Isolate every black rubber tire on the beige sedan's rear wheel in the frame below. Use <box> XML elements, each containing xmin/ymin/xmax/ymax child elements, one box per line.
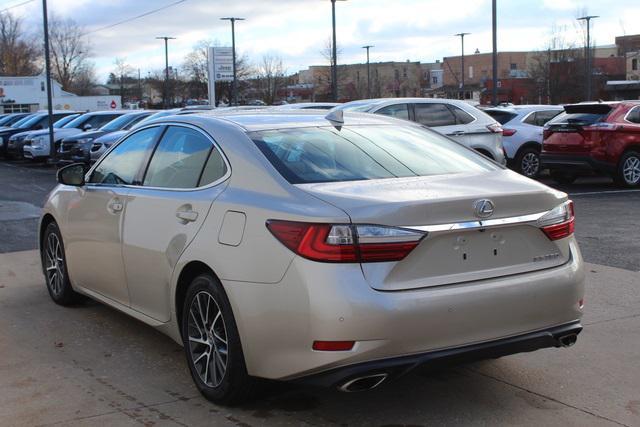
<box><xmin>181</xmin><ymin>273</ymin><xmax>257</xmax><ymax>405</ymax></box>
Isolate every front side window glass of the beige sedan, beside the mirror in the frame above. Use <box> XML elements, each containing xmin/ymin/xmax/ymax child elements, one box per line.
<box><xmin>89</xmin><ymin>127</ymin><xmax>161</xmax><ymax>185</ymax></box>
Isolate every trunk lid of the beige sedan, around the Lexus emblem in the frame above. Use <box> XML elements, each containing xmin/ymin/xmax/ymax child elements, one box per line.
<box><xmin>297</xmin><ymin>170</ymin><xmax>569</xmax><ymax>291</ymax></box>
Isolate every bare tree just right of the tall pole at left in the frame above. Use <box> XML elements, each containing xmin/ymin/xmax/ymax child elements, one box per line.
<box><xmin>49</xmin><ymin>16</ymin><xmax>91</xmax><ymax>90</ymax></box>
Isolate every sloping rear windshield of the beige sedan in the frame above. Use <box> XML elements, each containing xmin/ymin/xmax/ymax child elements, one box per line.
<box><xmin>249</xmin><ymin>125</ymin><xmax>500</xmax><ymax>184</ymax></box>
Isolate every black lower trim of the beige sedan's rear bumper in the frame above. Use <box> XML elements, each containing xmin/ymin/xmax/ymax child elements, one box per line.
<box><xmin>293</xmin><ymin>321</ymin><xmax>582</xmax><ymax>387</ymax></box>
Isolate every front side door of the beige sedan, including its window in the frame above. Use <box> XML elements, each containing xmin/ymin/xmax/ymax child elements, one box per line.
<box><xmin>65</xmin><ymin>127</ymin><xmax>161</xmax><ymax>305</ymax></box>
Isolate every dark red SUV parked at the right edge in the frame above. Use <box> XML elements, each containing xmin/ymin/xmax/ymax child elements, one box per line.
<box><xmin>541</xmin><ymin>101</ymin><xmax>640</xmax><ymax>187</ymax></box>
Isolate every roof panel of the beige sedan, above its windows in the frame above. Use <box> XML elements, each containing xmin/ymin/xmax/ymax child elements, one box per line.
<box><xmin>159</xmin><ymin>109</ymin><xmax>412</xmax><ymax>132</ymax></box>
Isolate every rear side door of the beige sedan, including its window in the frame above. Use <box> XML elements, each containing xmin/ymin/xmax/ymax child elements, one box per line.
<box><xmin>123</xmin><ymin>125</ymin><xmax>229</xmax><ymax>322</ymax></box>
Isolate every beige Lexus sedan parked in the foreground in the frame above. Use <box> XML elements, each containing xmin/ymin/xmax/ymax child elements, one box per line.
<box><xmin>40</xmin><ymin>111</ymin><xmax>584</xmax><ymax>404</ymax></box>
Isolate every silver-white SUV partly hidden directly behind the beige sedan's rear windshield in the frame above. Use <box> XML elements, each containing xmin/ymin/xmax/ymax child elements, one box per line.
<box><xmin>334</xmin><ymin>98</ymin><xmax>506</xmax><ymax>164</ymax></box>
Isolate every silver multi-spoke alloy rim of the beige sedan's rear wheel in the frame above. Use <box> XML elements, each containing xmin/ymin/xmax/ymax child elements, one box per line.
<box><xmin>187</xmin><ymin>291</ymin><xmax>229</xmax><ymax>388</ymax></box>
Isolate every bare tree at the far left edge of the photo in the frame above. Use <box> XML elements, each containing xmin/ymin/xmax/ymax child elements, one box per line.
<box><xmin>0</xmin><ymin>13</ymin><xmax>40</xmax><ymax>76</ymax></box>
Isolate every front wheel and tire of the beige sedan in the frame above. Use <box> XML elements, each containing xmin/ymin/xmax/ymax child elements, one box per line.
<box><xmin>40</xmin><ymin>222</ymin><xmax>81</xmax><ymax>306</ymax></box>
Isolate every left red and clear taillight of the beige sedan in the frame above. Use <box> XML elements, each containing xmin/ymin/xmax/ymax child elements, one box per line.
<box><xmin>267</xmin><ymin>220</ymin><xmax>426</xmax><ymax>262</ymax></box>
